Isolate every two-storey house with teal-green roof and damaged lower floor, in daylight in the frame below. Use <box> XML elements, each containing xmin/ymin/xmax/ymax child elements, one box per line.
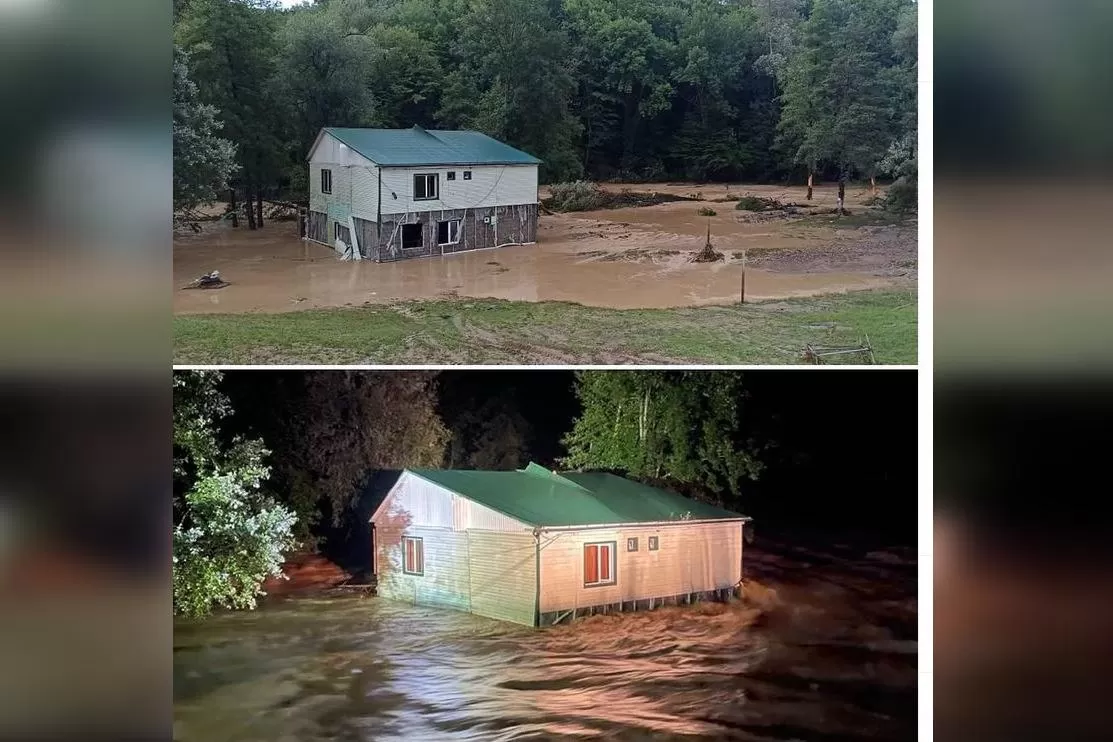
<box><xmin>303</xmin><ymin>126</ymin><xmax>541</xmax><ymax>261</ymax></box>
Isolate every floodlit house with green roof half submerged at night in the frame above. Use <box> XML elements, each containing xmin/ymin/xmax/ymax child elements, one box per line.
<box><xmin>371</xmin><ymin>464</ymin><xmax>749</xmax><ymax>626</ymax></box>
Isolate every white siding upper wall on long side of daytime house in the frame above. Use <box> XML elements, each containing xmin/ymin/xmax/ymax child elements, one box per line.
<box><xmin>383</xmin><ymin>165</ymin><xmax>538</xmax><ymax>214</ymax></box>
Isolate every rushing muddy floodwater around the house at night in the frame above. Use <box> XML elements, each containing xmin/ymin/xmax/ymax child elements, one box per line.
<box><xmin>174</xmin><ymin>545</ymin><xmax>916</xmax><ymax>742</ymax></box>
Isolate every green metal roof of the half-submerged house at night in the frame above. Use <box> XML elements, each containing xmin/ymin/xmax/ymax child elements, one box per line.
<box><xmin>410</xmin><ymin>464</ymin><xmax>745</xmax><ymax>527</ymax></box>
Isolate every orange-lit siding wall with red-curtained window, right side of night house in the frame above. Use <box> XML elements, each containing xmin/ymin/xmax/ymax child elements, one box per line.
<box><xmin>540</xmin><ymin>522</ymin><xmax>742</xmax><ymax>613</ymax></box>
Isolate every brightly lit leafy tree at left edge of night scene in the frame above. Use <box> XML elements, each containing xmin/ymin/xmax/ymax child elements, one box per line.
<box><xmin>174</xmin><ymin>372</ymin><xmax>295</xmax><ymax>617</ymax></box>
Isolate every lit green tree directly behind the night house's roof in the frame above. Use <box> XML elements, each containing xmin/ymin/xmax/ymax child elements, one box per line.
<box><xmin>563</xmin><ymin>372</ymin><xmax>762</xmax><ymax>495</ymax></box>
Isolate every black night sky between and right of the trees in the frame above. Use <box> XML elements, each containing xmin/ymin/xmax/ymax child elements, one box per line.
<box><xmin>440</xmin><ymin>369</ymin><xmax>917</xmax><ymax>543</ymax></box>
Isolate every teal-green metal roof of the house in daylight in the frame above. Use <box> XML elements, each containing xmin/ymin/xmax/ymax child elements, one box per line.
<box><xmin>324</xmin><ymin>126</ymin><xmax>541</xmax><ymax>167</ymax></box>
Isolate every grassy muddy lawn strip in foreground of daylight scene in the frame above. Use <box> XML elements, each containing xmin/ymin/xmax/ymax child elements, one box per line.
<box><xmin>174</xmin><ymin>290</ymin><xmax>916</xmax><ymax>364</ymax></box>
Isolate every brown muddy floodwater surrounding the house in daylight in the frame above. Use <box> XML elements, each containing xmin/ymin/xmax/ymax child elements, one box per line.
<box><xmin>174</xmin><ymin>184</ymin><xmax>916</xmax><ymax>314</ymax></box>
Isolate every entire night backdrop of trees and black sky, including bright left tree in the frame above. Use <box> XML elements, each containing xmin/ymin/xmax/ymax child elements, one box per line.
<box><xmin>174</xmin><ymin>372</ymin><xmax>916</xmax><ymax>615</ymax></box>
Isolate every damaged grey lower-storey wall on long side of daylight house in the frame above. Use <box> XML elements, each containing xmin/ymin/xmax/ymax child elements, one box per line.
<box><xmin>355</xmin><ymin>204</ymin><xmax>538</xmax><ymax>261</ymax></box>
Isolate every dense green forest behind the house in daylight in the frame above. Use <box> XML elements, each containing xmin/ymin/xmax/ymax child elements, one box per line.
<box><xmin>174</xmin><ymin>0</ymin><xmax>917</xmax><ymax>218</ymax></box>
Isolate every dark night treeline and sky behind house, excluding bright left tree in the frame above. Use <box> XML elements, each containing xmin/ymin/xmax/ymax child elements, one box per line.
<box><xmin>214</xmin><ymin>372</ymin><xmax>916</xmax><ymax>538</ymax></box>
